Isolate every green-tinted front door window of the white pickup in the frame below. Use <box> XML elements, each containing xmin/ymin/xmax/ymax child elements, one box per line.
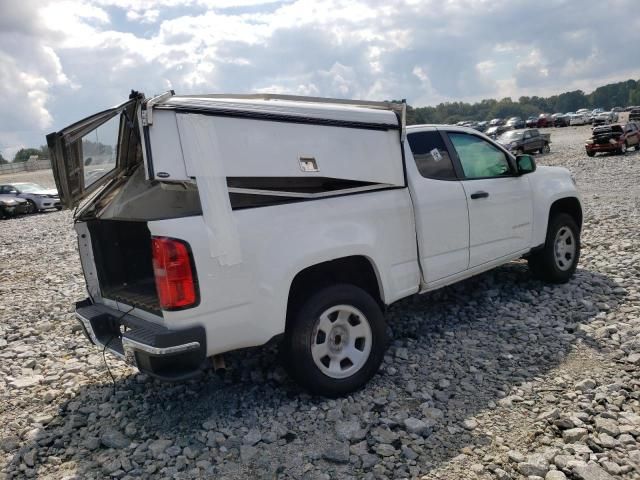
<box><xmin>449</xmin><ymin>132</ymin><xmax>511</xmax><ymax>178</ymax></box>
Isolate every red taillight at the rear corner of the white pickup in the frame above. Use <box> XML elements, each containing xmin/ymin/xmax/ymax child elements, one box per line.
<box><xmin>151</xmin><ymin>237</ymin><xmax>198</xmax><ymax>310</ymax></box>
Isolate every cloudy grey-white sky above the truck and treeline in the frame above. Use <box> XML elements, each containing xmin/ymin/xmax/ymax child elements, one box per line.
<box><xmin>0</xmin><ymin>0</ymin><xmax>640</xmax><ymax>158</ymax></box>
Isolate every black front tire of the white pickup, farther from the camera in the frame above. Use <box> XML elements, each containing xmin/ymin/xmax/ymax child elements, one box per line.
<box><xmin>528</xmin><ymin>213</ymin><xmax>580</xmax><ymax>283</ymax></box>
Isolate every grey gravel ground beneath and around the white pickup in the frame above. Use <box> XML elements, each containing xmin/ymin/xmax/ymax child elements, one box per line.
<box><xmin>0</xmin><ymin>127</ymin><xmax>640</xmax><ymax>480</ymax></box>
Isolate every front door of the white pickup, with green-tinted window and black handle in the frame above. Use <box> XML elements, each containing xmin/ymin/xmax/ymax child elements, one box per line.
<box><xmin>448</xmin><ymin>131</ymin><xmax>533</xmax><ymax>268</ymax></box>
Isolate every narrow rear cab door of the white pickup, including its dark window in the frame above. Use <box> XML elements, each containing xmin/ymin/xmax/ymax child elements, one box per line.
<box><xmin>405</xmin><ymin>129</ymin><xmax>469</xmax><ymax>284</ymax></box>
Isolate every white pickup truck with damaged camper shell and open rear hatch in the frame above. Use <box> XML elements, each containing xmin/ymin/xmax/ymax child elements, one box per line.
<box><xmin>47</xmin><ymin>92</ymin><xmax>582</xmax><ymax>396</ymax></box>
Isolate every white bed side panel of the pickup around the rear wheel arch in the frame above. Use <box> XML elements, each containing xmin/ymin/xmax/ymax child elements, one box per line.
<box><xmin>149</xmin><ymin>188</ymin><xmax>420</xmax><ymax>355</ymax></box>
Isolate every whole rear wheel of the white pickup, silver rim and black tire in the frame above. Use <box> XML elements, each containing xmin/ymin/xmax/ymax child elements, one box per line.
<box><xmin>285</xmin><ymin>284</ymin><xmax>387</xmax><ymax>397</ymax></box>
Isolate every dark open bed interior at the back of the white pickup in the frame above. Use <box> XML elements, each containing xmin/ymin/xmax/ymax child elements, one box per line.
<box><xmin>88</xmin><ymin>220</ymin><xmax>162</xmax><ymax>315</ymax></box>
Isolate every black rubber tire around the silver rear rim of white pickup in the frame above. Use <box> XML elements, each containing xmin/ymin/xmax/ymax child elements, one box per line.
<box><xmin>284</xmin><ymin>284</ymin><xmax>387</xmax><ymax>398</ymax></box>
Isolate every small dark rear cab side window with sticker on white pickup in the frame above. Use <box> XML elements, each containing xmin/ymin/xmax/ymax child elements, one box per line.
<box><xmin>407</xmin><ymin>131</ymin><xmax>456</xmax><ymax>180</ymax></box>
